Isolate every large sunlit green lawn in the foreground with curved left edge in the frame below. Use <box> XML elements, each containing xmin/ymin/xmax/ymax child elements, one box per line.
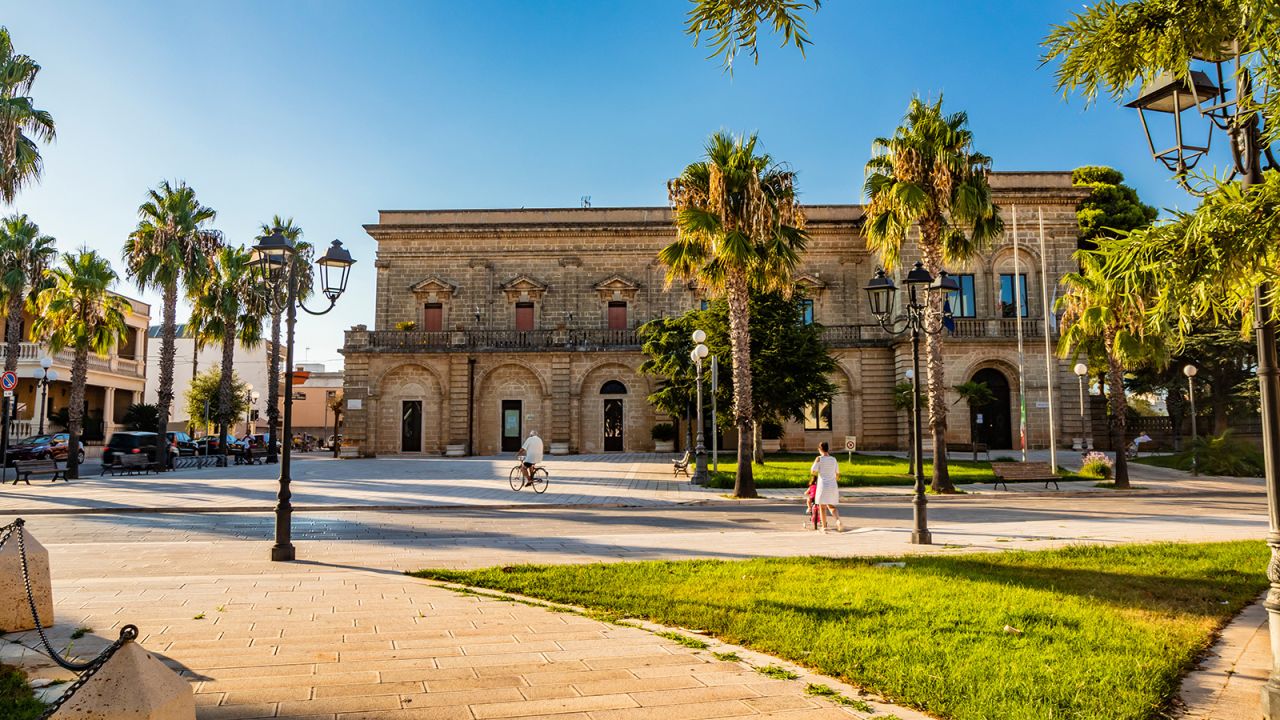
<box><xmin>416</xmin><ymin>542</ymin><xmax>1267</xmax><ymax>720</ymax></box>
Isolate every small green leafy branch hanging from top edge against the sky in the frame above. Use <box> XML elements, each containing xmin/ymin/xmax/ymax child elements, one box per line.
<box><xmin>685</xmin><ymin>0</ymin><xmax>822</xmax><ymax>73</ymax></box>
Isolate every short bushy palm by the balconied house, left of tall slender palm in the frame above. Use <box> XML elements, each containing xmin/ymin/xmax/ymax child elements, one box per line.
<box><xmin>32</xmin><ymin>250</ymin><xmax>129</xmax><ymax>478</ymax></box>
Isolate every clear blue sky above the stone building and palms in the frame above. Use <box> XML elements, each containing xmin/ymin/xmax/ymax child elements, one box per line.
<box><xmin>0</xmin><ymin>0</ymin><xmax>1190</xmax><ymax>363</ymax></box>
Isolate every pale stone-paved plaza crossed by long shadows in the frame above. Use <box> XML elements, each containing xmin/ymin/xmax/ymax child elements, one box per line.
<box><xmin>0</xmin><ymin>456</ymin><xmax>1270</xmax><ymax>720</ymax></box>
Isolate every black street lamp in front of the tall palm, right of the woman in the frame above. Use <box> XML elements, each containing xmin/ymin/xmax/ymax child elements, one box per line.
<box><xmin>865</xmin><ymin>263</ymin><xmax>960</xmax><ymax>544</ymax></box>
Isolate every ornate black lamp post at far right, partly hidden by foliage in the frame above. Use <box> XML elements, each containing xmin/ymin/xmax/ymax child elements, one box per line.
<box><xmin>1128</xmin><ymin>41</ymin><xmax>1280</xmax><ymax>719</ymax></box>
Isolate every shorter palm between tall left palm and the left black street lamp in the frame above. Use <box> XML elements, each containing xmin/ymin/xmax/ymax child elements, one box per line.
<box><xmin>191</xmin><ymin>247</ymin><xmax>266</xmax><ymax>455</ymax></box>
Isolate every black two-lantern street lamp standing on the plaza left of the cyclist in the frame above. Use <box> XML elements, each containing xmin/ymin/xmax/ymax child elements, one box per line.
<box><xmin>253</xmin><ymin>228</ymin><xmax>356</xmax><ymax>560</ymax></box>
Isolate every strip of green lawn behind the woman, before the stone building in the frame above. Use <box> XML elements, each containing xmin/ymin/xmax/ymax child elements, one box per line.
<box><xmin>709</xmin><ymin>452</ymin><xmax>995</xmax><ymax>488</ymax></box>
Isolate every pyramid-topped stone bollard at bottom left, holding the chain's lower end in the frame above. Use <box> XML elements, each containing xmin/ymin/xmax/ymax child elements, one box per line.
<box><xmin>50</xmin><ymin>642</ymin><xmax>196</xmax><ymax>720</ymax></box>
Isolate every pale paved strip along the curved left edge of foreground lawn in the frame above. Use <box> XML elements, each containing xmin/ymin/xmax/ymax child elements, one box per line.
<box><xmin>406</xmin><ymin>573</ymin><xmax>938</xmax><ymax>720</ymax></box>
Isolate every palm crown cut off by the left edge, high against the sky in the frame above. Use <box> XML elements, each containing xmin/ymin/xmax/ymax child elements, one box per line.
<box><xmin>0</xmin><ymin>27</ymin><xmax>58</xmax><ymax>205</ymax></box>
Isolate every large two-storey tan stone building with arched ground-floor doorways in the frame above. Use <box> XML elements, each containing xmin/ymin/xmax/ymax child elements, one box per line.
<box><xmin>343</xmin><ymin>172</ymin><xmax>1087</xmax><ymax>455</ymax></box>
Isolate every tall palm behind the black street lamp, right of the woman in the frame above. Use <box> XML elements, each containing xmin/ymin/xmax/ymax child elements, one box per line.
<box><xmin>864</xmin><ymin>97</ymin><xmax>1004</xmax><ymax>492</ymax></box>
